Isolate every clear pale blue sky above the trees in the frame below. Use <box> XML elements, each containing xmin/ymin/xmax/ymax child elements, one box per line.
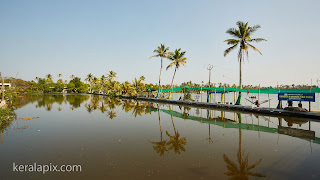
<box><xmin>0</xmin><ymin>0</ymin><xmax>320</xmax><ymax>86</ymax></box>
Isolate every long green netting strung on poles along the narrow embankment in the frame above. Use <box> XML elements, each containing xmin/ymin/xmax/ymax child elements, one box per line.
<box><xmin>150</xmin><ymin>86</ymin><xmax>320</xmax><ymax>94</ymax></box>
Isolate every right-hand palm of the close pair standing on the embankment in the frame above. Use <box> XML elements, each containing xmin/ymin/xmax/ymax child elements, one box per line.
<box><xmin>167</xmin><ymin>48</ymin><xmax>188</xmax><ymax>95</ymax></box>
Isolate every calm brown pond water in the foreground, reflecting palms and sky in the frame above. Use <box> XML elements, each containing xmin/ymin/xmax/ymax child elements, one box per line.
<box><xmin>0</xmin><ymin>94</ymin><xmax>320</xmax><ymax>180</ymax></box>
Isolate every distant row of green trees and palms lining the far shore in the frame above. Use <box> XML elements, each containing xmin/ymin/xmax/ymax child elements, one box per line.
<box><xmin>5</xmin><ymin>71</ymin><xmax>318</xmax><ymax>96</ymax></box>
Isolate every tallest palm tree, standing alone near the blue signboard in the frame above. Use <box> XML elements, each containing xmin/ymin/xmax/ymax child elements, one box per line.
<box><xmin>224</xmin><ymin>21</ymin><xmax>267</xmax><ymax>105</ymax></box>
